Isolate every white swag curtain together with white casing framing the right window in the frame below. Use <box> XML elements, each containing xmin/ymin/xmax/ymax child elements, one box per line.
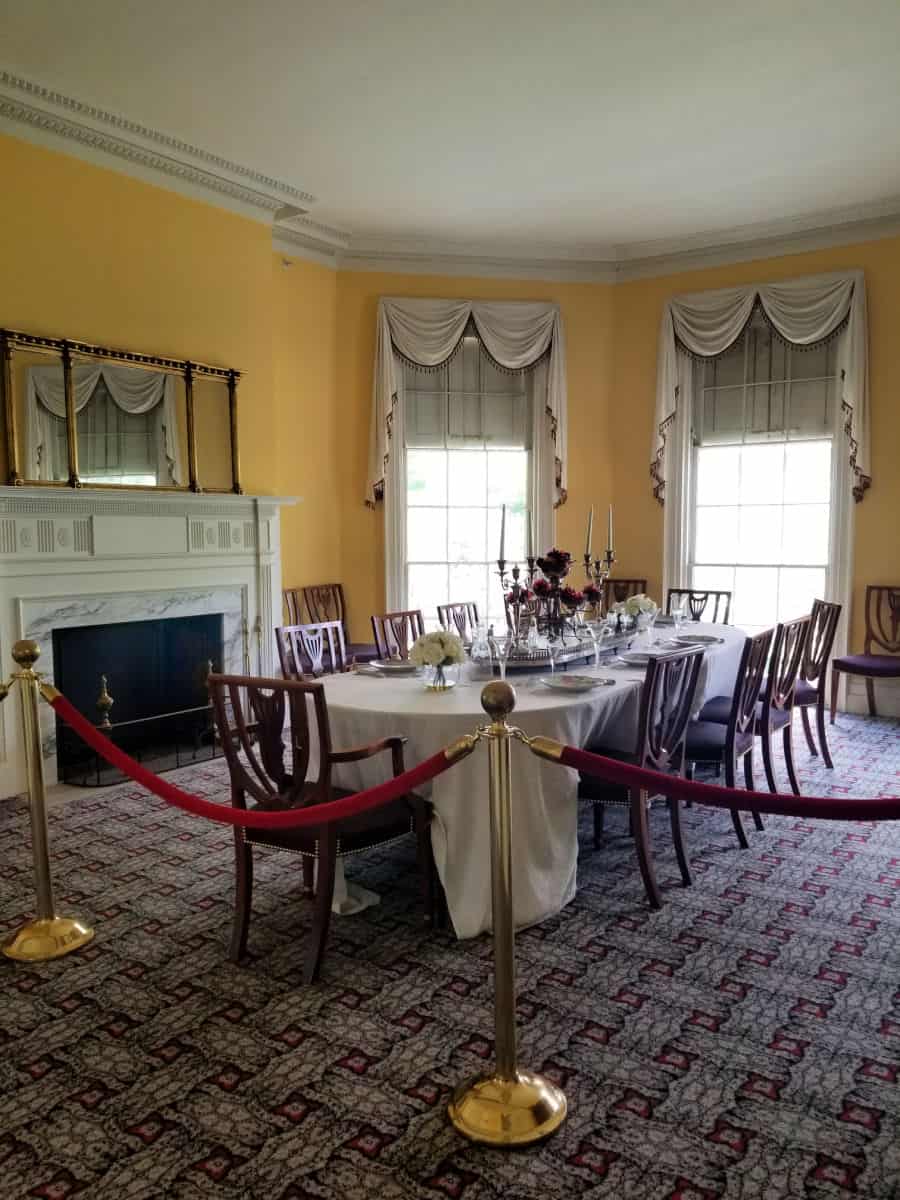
<box><xmin>650</xmin><ymin>270</ymin><xmax>871</xmax><ymax>667</ymax></box>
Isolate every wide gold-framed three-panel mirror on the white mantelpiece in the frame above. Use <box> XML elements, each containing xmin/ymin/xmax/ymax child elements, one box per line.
<box><xmin>0</xmin><ymin>329</ymin><xmax>242</xmax><ymax>493</ymax></box>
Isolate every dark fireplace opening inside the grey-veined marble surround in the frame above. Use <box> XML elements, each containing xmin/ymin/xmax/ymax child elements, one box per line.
<box><xmin>53</xmin><ymin>613</ymin><xmax>223</xmax><ymax>787</ymax></box>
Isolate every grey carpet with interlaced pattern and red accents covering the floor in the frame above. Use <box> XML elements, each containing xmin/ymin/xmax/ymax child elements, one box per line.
<box><xmin>0</xmin><ymin>716</ymin><xmax>900</xmax><ymax>1200</ymax></box>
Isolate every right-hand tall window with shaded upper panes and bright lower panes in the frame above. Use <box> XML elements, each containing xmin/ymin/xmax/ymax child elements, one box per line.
<box><xmin>690</xmin><ymin>313</ymin><xmax>840</xmax><ymax>632</ymax></box>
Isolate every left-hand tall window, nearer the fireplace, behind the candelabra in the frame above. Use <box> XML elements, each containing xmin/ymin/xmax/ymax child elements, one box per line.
<box><xmin>404</xmin><ymin>335</ymin><xmax>532</xmax><ymax>628</ymax></box>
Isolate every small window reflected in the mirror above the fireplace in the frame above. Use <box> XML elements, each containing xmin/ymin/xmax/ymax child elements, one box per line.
<box><xmin>52</xmin><ymin>378</ymin><xmax>160</xmax><ymax>487</ymax></box>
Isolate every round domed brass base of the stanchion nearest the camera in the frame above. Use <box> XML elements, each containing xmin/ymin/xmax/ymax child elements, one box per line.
<box><xmin>448</xmin><ymin>1070</ymin><xmax>566</xmax><ymax>1146</ymax></box>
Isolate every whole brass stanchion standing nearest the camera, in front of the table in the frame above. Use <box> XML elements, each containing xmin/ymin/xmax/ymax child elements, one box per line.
<box><xmin>448</xmin><ymin>682</ymin><xmax>566</xmax><ymax>1146</ymax></box>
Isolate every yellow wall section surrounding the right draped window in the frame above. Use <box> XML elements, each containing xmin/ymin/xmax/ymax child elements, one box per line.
<box><xmin>613</xmin><ymin>238</ymin><xmax>900</xmax><ymax>649</ymax></box>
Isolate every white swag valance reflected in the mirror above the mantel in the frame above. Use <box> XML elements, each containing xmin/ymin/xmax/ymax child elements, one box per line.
<box><xmin>25</xmin><ymin>362</ymin><xmax>182</xmax><ymax>484</ymax></box>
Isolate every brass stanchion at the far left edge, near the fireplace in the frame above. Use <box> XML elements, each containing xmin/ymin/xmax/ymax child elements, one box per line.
<box><xmin>0</xmin><ymin>641</ymin><xmax>94</xmax><ymax>962</ymax></box>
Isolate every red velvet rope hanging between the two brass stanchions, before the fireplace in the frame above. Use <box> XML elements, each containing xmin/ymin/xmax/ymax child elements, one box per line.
<box><xmin>49</xmin><ymin>695</ymin><xmax>452</xmax><ymax>829</ymax></box>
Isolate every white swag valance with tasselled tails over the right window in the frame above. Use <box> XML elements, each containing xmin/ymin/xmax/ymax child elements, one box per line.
<box><xmin>650</xmin><ymin>271</ymin><xmax>871</xmax><ymax>503</ymax></box>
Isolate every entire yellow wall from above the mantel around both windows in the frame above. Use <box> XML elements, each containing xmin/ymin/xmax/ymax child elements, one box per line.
<box><xmin>0</xmin><ymin>137</ymin><xmax>900</xmax><ymax>644</ymax></box>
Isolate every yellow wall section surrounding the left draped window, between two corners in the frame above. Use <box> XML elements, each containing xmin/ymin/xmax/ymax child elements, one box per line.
<box><xmin>337</xmin><ymin>271</ymin><xmax>613</xmax><ymax>638</ymax></box>
